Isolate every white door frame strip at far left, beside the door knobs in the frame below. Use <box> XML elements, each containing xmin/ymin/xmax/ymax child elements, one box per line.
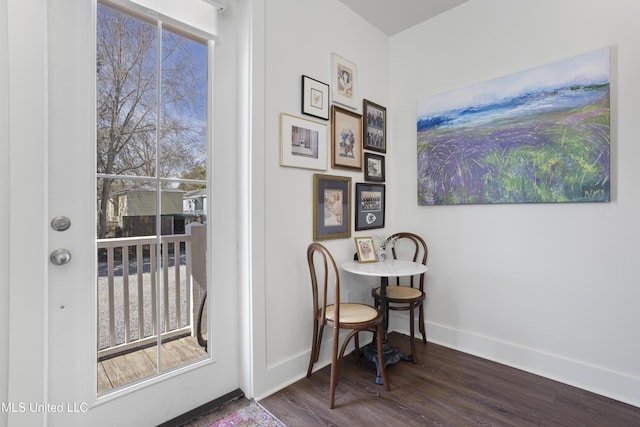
<box><xmin>3</xmin><ymin>0</ymin><xmax>48</xmax><ymax>425</ymax></box>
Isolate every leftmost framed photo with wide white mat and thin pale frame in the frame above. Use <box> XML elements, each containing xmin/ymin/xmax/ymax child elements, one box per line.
<box><xmin>280</xmin><ymin>113</ymin><xmax>328</xmax><ymax>170</ymax></box>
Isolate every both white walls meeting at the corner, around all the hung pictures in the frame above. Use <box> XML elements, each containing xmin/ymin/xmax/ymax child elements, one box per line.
<box><xmin>252</xmin><ymin>0</ymin><xmax>640</xmax><ymax>406</ymax></box>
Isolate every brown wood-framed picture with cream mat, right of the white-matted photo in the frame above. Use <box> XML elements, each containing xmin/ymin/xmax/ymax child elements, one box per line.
<box><xmin>331</xmin><ymin>105</ymin><xmax>362</xmax><ymax>170</ymax></box>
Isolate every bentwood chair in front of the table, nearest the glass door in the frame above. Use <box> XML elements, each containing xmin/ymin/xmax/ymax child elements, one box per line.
<box><xmin>307</xmin><ymin>243</ymin><xmax>390</xmax><ymax>409</ymax></box>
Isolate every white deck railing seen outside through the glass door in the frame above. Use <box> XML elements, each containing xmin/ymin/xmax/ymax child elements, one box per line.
<box><xmin>97</xmin><ymin>234</ymin><xmax>200</xmax><ymax>359</ymax></box>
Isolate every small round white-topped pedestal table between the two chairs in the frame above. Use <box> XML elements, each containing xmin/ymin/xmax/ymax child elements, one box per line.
<box><xmin>340</xmin><ymin>259</ymin><xmax>427</xmax><ymax>384</ymax></box>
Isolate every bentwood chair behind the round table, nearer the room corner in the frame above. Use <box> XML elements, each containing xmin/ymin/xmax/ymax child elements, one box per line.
<box><xmin>371</xmin><ymin>232</ymin><xmax>428</xmax><ymax>363</ymax></box>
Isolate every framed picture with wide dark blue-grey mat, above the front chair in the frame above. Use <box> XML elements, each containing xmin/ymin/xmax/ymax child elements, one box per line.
<box><xmin>313</xmin><ymin>174</ymin><xmax>351</xmax><ymax>240</ymax></box>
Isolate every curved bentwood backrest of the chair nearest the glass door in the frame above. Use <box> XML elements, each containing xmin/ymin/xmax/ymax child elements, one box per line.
<box><xmin>307</xmin><ymin>243</ymin><xmax>340</xmax><ymax>319</ymax></box>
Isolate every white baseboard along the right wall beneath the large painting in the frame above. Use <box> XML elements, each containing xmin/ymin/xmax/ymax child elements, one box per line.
<box><xmin>389</xmin><ymin>313</ymin><xmax>640</xmax><ymax>407</ymax></box>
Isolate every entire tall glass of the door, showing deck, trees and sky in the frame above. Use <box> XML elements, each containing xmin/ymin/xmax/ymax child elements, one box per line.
<box><xmin>96</xmin><ymin>5</ymin><xmax>209</xmax><ymax>393</ymax></box>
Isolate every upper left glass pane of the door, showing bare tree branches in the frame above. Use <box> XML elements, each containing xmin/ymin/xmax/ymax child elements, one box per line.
<box><xmin>96</xmin><ymin>5</ymin><xmax>158</xmax><ymax>182</ymax></box>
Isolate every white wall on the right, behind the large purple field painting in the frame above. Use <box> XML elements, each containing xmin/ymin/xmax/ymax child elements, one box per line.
<box><xmin>387</xmin><ymin>0</ymin><xmax>640</xmax><ymax>406</ymax></box>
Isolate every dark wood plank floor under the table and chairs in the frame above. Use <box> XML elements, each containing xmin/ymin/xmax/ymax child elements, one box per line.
<box><xmin>260</xmin><ymin>333</ymin><xmax>640</xmax><ymax>427</ymax></box>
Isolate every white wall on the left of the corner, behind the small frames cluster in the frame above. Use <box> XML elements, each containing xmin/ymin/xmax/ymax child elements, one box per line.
<box><xmin>252</xmin><ymin>0</ymin><xmax>389</xmax><ymax>397</ymax></box>
